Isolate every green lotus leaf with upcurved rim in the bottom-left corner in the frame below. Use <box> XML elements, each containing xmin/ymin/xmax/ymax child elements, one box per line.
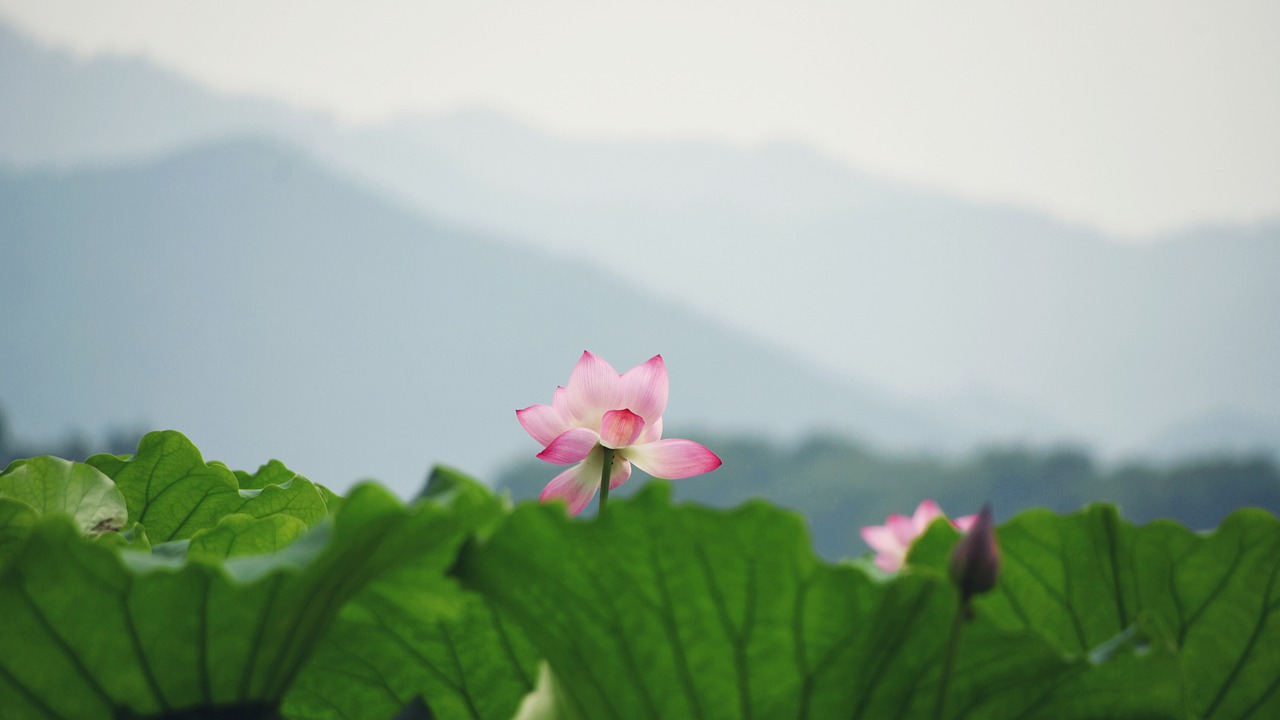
<box><xmin>0</xmin><ymin>476</ymin><xmax>483</xmax><ymax>720</ymax></box>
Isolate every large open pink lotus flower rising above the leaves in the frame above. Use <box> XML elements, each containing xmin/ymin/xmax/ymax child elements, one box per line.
<box><xmin>516</xmin><ymin>352</ymin><xmax>721</xmax><ymax>515</ymax></box>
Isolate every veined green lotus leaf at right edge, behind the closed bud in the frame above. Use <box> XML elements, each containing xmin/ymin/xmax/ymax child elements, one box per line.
<box><xmin>910</xmin><ymin>505</ymin><xmax>1280</xmax><ymax>717</ymax></box>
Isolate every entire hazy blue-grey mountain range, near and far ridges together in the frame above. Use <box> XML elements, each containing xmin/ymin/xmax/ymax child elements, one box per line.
<box><xmin>0</xmin><ymin>18</ymin><xmax>1280</xmax><ymax>486</ymax></box>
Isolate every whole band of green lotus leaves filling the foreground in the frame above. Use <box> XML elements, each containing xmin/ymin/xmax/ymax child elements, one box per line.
<box><xmin>0</xmin><ymin>430</ymin><xmax>1280</xmax><ymax>720</ymax></box>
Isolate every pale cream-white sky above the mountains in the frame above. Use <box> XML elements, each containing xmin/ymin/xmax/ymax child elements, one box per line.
<box><xmin>0</xmin><ymin>0</ymin><xmax>1280</xmax><ymax>240</ymax></box>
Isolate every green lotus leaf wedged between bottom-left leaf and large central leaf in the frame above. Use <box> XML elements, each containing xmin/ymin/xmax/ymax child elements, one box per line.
<box><xmin>284</xmin><ymin>468</ymin><xmax>538</xmax><ymax>720</ymax></box>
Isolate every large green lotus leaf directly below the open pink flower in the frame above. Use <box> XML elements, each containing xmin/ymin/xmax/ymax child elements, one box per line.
<box><xmin>456</xmin><ymin>483</ymin><xmax>1183</xmax><ymax>719</ymax></box>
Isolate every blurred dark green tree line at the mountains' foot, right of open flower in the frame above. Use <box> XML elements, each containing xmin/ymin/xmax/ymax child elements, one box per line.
<box><xmin>495</xmin><ymin>427</ymin><xmax>1280</xmax><ymax>557</ymax></box>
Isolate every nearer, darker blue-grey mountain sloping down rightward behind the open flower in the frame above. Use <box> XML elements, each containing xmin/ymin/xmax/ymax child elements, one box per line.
<box><xmin>0</xmin><ymin>140</ymin><xmax>960</xmax><ymax>493</ymax></box>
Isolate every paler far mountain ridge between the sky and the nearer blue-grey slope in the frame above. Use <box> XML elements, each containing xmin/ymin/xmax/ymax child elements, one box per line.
<box><xmin>0</xmin><ymin>19</ymin><xmax>1280</xmax><ymax>454</ymax></box>
